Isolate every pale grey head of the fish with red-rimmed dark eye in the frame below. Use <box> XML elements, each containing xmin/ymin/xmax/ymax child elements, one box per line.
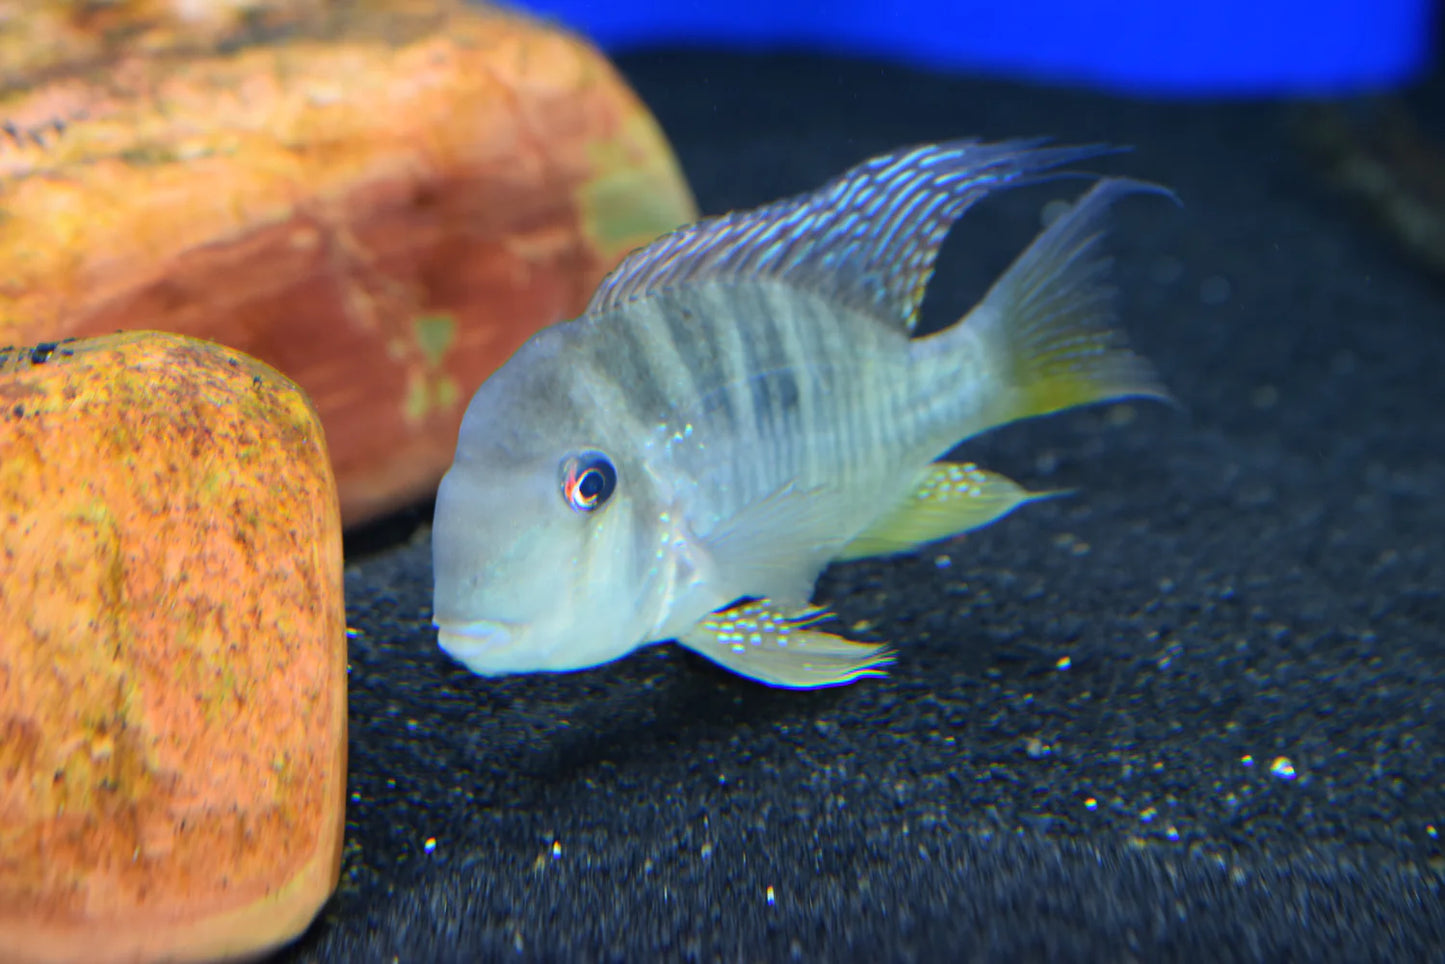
<box><xmin>432</xmin><ymin>330</ymin><xmax>660</xmax><ymax>676</ymax></box>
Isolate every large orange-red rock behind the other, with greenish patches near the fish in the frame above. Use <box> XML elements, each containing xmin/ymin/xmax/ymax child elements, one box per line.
<box><xmin>0</xmin><ymin>0</ymin><xmax>696</xmax><ymax>525</ymax></box>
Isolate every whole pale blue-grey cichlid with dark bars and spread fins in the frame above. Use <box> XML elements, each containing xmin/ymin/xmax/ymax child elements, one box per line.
<box><xmin>432</xmin><ymin>140</ymin><xmax>1172</xmax><ymax>688</ymax></box>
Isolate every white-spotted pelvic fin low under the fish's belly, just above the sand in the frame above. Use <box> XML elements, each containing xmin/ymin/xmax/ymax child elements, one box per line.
<box><xmin>678</xmin><ymin>600</ymin><xmax>894</xmax><ymax>689</ymax></box>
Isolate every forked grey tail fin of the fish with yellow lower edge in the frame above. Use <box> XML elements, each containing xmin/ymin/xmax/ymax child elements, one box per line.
<box><xmin>938</xmin><ymin>178</ymin><xmax>1175</xmax><ymax>434</ymax></box>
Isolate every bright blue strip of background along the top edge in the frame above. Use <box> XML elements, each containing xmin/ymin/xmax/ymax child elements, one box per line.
<box><xmin>517</xmin><ymin>0</ymin><xmax>1432</xmax><ymax>95</ymax></box>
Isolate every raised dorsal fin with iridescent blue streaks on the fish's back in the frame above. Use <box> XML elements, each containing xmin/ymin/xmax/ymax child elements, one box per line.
<box><xmin>587</xmin><ymin>140</ymin><xmax>1116</xmax><ymax>331</ymax></box>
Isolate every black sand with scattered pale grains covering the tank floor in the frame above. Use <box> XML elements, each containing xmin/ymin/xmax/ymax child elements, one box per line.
<box><xmin>285</xmin><ymin>53</ymin><xmax>1445</xmax><ymax>963</ymax></box>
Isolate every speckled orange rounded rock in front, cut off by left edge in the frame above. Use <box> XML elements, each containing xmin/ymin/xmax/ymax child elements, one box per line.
<box><xmin>0</xmin><ymin>332</ymin><xmax>347</xmax><ymax>964</ymax></box>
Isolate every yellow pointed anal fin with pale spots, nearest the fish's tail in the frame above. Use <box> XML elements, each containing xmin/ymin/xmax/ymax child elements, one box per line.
<box><xmin>838</xmin><ymin>462</ymin><xmax>1066</xmax><ymax>559</ymax></box>
